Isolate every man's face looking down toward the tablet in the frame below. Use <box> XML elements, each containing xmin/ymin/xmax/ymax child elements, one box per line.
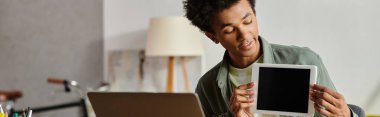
<box><xmin>206</xmin><ymin>0</ymin><xmax>260</xmax><ymax>58</ymax></box>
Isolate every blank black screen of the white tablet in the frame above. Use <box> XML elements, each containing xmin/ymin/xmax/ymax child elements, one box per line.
<box><xmin>257</xmin><ymin>67</ymin><xmax>310</xmax><ymax>113</ymax></box>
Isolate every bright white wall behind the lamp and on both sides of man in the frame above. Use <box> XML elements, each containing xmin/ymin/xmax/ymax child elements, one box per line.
<box><xmin>104</xmin><ymin>0</ymin><xmax>380</xmax><ymax>114</ymax></box>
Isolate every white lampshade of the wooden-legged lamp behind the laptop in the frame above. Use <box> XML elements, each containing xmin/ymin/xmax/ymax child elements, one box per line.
<box><xmin>145</xmin><ymin>16</ymin><xmax>203</xmax><ymax>56</ymax></box>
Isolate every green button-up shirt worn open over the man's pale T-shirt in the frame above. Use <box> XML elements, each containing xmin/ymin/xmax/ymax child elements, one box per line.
<box><xmin>195</xmin><ymin>37</ymin><xmax>357</xmax><ymax>117</ymax></box>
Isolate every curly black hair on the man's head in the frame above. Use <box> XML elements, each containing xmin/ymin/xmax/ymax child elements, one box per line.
<box><xmin>183</xmin><ymin>0</ymin><xmax>256</xmax><ymax>33</ymax></box>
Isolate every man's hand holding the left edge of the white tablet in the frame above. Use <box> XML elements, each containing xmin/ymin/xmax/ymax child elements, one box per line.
<box><xmin>229</xmin><ymin>82</ymin><xmax>254</xmax><ymax>117</ymax></box>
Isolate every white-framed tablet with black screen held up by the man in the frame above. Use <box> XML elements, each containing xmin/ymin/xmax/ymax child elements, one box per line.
<box><xmin>252</xmin><ymin>63</ymin><xmax>317</xmax><ymax>117</ymax></box>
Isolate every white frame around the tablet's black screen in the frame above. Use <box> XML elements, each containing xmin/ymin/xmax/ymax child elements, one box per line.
<box><xmin>251</xmin><ymin>63</ymin><xmax>317</xmax><ymax>117</ymax></box>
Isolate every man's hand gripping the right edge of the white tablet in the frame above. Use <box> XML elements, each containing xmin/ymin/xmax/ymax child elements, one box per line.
<box><xmin>310</xmin><ymin>85</ymin><xmax>351</xmax><ymax>117</ymax></box>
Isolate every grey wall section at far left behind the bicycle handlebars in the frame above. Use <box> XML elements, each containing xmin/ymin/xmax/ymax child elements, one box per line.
<box><xmin>0</xmin><ymin>0</ymin><xmax>103</xmax><ymax>117</ymax></box>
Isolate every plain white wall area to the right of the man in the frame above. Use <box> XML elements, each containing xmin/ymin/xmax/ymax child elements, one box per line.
<box><xmin>257</xmin><ymin>0</ymin><xmax>380</xmax><ymax>114</ymax></box>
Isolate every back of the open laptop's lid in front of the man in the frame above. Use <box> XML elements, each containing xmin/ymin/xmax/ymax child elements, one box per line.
<box><xmin>88</xmin><ymin>92</ymin><xmax>204</xmax><ymax>117</ymax></box>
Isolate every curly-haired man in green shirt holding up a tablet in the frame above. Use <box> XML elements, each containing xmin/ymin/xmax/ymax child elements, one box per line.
<box><xmin>184</xmin><ymin>0</ymin><xmax>357</xmax><ymax>117</ymax></box>
